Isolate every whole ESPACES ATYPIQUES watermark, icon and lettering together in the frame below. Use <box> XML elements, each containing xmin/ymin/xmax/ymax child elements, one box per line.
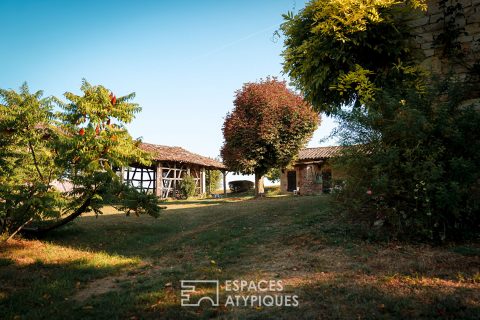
<box><xmin>180</xmin><ymin>280</ymin><xmax>299</xmax><ymax>307</ymax></box>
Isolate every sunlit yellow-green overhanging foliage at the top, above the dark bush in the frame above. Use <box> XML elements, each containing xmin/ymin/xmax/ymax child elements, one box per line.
<box><xmin>281</xmin><ymin>0</ymin><xmax>425</xmax><ymax>115</ymax></box>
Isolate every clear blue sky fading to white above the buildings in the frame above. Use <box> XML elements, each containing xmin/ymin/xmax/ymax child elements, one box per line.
<box><xmin>0</xmin><ymin>0</ymin><xmax>333</xmax><ymax>181</ymax></box>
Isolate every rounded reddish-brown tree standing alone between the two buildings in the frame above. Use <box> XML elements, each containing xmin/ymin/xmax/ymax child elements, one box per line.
<box><xmin>221</xmin><ymin>78</ymin><xmax>319</xmax><ymax>196</ymax></box>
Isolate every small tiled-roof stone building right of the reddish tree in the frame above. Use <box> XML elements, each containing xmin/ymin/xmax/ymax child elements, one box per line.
<box><xmin>280</xmin><ymin>146</ymin><xmax>343</xmax><ymax>195</ymax></box>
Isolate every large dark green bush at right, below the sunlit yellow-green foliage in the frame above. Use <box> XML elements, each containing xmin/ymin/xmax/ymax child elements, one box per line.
<box><xmin>337</xmin><ymin>75</ymin><xmax>480</xmax><ymax>241</ymax></box>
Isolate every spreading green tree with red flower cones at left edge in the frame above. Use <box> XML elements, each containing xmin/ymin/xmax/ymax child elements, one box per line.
<box><xmin>0</xmin><ymin>80</ymin><xmax>159</xmax><ymax>238</ymax></box>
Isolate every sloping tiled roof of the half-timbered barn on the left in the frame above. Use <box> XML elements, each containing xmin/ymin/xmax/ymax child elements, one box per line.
<box><xmin>140</xmin><ymin>143</ymin><xmax>226</xmax><ymax>170</ymax></box>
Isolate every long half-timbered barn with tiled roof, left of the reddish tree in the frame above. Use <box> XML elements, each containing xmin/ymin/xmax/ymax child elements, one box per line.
<box><xmin>120</xmin><ymin>143</ymin><xmax>226</xmax><ymax>199</ymax></box>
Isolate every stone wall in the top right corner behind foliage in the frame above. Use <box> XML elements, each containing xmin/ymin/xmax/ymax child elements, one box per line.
<box><xmin>409</xmin><ymin>0</ymin><xmax>480</xmax><ymax>98</ymax></box>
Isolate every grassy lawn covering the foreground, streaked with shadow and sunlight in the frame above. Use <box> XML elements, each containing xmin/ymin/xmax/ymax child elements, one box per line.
<box><xmin>0</xmin><ymin>196</ymin><xmax>480</xmax><ymax>319</ymax></box>
